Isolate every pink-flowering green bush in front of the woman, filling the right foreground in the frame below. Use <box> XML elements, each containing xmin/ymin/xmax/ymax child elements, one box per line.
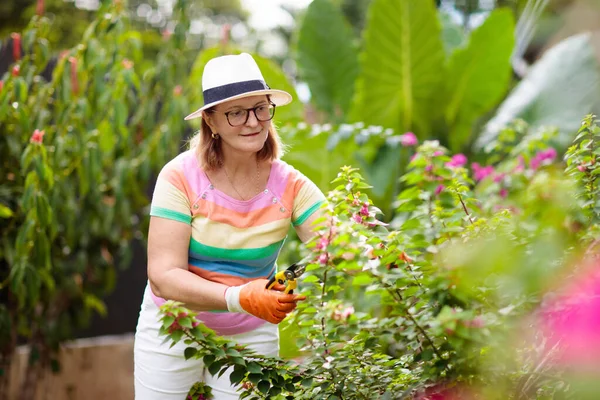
<box><xmin>162</xmin><ymin>116</ymin><xmax>600</xmax><ymax>399</ymax></box>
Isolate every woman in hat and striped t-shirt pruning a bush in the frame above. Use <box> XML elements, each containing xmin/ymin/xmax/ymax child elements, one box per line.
<box><xmin>134</xmin><ymin>53</ymin><xmax>325</xmax><ymax>400</ymax></box>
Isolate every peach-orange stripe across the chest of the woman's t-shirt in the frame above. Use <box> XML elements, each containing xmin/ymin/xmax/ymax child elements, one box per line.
<box><xmin>194</xmin><ymin>201</ymin><xmax>292</xmax><ymax>228</ymax></box>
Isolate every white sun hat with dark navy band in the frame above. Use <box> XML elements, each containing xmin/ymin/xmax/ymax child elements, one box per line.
<box><xmin>185</xmin><ymin>53</ymin><xmax>292</xmax><ymax>120</ymax></box>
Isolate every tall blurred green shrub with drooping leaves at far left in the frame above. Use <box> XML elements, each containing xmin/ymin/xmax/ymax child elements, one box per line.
<box><xmin>0</xmin><ymin>2</ymin><xmax>195</xmax><ymax>387</ymax></box>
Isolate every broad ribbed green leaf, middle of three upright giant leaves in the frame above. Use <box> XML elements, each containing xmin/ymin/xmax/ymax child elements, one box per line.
<box><xmin>352</xmin><ymin>0</ymin><xmax>445</xmax><ymax>137</ymax></box>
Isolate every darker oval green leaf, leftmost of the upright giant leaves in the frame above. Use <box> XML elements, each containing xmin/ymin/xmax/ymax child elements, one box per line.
<box><xmin>297</xmin><ymin>0</ymin><xmax>358</xmax><ymax>120</ymax></box>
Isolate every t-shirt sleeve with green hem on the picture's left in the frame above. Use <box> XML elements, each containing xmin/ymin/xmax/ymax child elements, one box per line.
<box><xmin>150</xmin><ymin>159</ymin><xmax>192</xmax><ymax>225</ymax></box>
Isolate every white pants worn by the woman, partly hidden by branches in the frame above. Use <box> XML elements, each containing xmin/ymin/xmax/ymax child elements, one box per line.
<box><xmin>133</xmin><ymin>287</ymin><xmax>279</xmax><ymax>400</ymax></box>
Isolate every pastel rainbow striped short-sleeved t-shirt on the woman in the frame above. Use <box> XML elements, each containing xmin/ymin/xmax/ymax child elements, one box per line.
<box><xmin>150</xmin><ymin>150</ymin><xmax>325</xmax><ymax>335</ymax></box>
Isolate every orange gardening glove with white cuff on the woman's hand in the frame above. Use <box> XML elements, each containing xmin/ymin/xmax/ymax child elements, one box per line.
<box><xmin>225</xmin><ymin>279</ymin><xmax>306</xmax><ymax>324</ymax></box>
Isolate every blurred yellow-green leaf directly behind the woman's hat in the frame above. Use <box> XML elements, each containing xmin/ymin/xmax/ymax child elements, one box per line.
<box><xmin>188</xmin><ymin>46</ymin><xmax>304</xmax><ymax>124</ymax></box>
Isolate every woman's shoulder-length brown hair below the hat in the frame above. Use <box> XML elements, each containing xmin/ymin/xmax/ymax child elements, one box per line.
<box><xmin>190</xmin><ymin>108</ymin><xmax>284</xmax><ymax>171</ymax></box>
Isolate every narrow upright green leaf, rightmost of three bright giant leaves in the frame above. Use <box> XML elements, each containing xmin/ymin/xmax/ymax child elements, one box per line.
<box><xmin>445</xmin><ymin>9</ymin><xmax>514</xmax><ymax>151</ymax></box>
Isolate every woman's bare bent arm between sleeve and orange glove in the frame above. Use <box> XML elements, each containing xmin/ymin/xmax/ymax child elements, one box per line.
<box><xmin>148</xmin><ymin>217</ymin><xmax>227</xmax><ymax>311</ymax></box>
